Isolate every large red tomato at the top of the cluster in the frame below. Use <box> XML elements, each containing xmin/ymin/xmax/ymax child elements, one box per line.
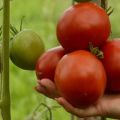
<box><xmin>56</xmin><ymin>2</ymin><xmax>111</xmax><ymax>52</ymax></box>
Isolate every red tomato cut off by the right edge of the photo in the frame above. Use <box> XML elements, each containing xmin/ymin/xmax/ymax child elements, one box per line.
<box><xmin>102</xmin><ymin>38</ymin><xmax>120</xmax><ymax>93</ymax></box>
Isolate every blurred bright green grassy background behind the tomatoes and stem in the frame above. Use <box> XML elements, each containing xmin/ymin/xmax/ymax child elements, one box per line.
<box><xmin>0</xmin><ymin>0</ymin><xmax>120</xmax><ymax>120</ymax></box>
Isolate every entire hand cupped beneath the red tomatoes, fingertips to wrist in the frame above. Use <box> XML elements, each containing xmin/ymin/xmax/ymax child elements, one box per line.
<box><xmin>36</xmin><ymin>79</ymin><xmax>120</xmax><ymax>118</ymax></box>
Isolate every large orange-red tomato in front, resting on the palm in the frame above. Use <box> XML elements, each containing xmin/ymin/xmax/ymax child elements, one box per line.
<box><xmin>55</xmin><ymin>50</ymin><xmax>106</xmax><ymax>108</ymax></box>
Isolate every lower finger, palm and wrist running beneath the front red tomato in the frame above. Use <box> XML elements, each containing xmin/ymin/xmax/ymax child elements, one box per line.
<box><xmin>55</xmin><ymin>95</ymin><xmax>120</xmax><ymax>118</ymax></box>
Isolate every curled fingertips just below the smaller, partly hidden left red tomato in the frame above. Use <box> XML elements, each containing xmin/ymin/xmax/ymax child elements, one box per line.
<box><xmin>35</xmin><ymin>78</ymin><xmax>60</xmax><ymax>99</ymax></box>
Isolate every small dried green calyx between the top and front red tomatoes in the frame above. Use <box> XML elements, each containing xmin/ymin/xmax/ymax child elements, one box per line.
<box><xmin>89</xmin><ymin>42</ymin><xmax>104</xmax><ymax>59</ymax></box>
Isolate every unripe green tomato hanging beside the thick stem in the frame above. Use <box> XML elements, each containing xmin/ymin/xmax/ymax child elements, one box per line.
<box><xmin>10</xmin><ymin>30</ymin><xmax>45</xmax><ymax>70</ymax></box>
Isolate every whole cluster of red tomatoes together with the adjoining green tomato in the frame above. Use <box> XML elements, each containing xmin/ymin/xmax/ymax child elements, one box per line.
<box><xmin>10</xmin><ymin>0</ymin><xmax>120</xmax><ymax>108</ymax></box>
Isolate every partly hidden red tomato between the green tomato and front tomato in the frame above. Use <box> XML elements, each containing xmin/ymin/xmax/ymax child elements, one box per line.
<box><xmin>35</xmin><ymin>46</ymin><xmax>65</xmax><ymax>80</ymax></box>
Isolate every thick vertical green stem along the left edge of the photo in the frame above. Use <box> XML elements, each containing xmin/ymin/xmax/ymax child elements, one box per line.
<box><xmin>1</xmin><ymin>0</ymin><xmax>11</xmax><ymax>120</ymax></box>
